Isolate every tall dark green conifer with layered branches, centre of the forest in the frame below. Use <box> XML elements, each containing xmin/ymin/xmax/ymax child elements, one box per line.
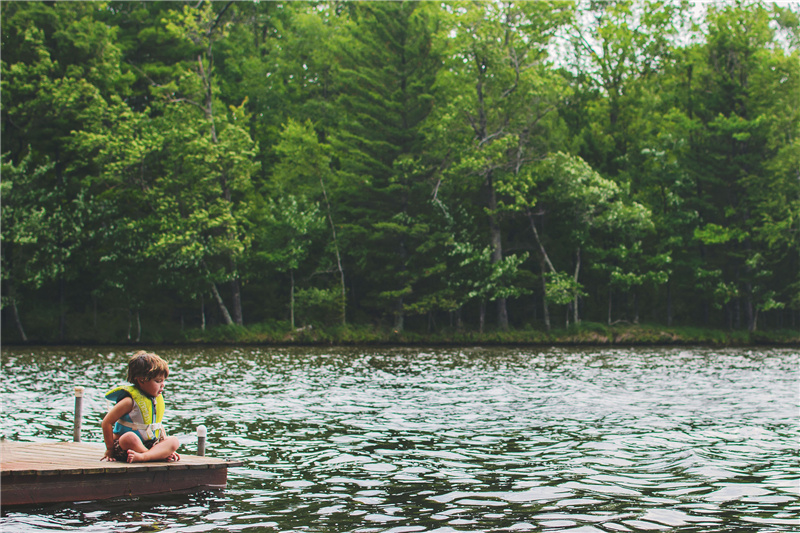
<box><xmin>330</xmin><ymin>2</ymin><xmax>441</xmax><ymax>331</ymax></box>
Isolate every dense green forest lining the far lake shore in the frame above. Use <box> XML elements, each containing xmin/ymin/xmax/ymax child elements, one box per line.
<box><xmin>0</xmin><ymin>0</ymin><xmax>800</xmax><ymax>342</ymax></box>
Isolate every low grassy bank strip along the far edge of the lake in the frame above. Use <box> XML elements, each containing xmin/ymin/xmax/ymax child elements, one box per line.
<box><xmin>3</xmin><ymin>322</ymin><xmax>800</xmax><ymax>347</ymax></box>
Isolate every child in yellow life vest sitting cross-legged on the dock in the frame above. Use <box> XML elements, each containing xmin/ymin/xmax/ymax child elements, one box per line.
<box><xmin>102</xmin><ymin>351</ymin><xmax>181</xmax><ymax>463</ymax></box>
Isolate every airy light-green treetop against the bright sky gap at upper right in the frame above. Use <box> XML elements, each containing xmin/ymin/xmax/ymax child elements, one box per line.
<box><xmin>565</xmin><ymin>0</ymin><xmax>688</xmax><ymax>177</ymax></box>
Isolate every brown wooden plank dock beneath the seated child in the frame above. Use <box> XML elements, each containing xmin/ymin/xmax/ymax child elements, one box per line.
<box><xmin>0</xmin><ymin>440</ymin><xmax>242</xmax><ymax>507</ymax></box>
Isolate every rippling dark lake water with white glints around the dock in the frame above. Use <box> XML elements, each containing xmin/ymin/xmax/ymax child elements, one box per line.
<box><xmin>0</xmin><ymin>347</ymin><xmax>800</xmax><ymax>533</ymax></box>
